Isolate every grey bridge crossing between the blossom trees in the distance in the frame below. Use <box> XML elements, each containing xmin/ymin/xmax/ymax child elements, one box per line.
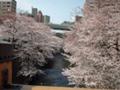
<box><xmin>48</xmin><ymin>24</ymin><xmax>71</xmax><ymax>31</ymax></box>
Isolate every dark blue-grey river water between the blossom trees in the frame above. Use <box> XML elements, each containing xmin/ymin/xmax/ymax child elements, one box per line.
<box><xmin>45</xmin><ymin>54</ymin><xmax>68</xmax><ymax>86</ymax></box>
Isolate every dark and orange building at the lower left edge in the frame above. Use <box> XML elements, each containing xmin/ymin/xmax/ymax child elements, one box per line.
<box><xmin>0</xmin><ymin>42</ymin><xmax>13</xmax><ymax>90</ymax></box>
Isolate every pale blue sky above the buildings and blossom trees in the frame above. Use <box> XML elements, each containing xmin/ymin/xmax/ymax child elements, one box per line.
<box><xmin>16</xmin><ymin>0</ymin><xmax>85</xmax><ymax>23</ymax></box>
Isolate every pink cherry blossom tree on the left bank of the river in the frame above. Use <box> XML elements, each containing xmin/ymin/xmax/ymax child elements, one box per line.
<box><xmin>0</xmin><ymin>15</ymin><xmax>62</xmax><ymax>78</ymax></box>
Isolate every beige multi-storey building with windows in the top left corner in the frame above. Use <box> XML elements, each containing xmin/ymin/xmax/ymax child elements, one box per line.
<box><xmin>0</xmin><ymin>0</ymin><xmax>17</xmax><ymax>15</ymax></box>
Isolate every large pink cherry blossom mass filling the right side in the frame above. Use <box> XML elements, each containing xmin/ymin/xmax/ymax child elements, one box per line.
<box><xmin>64</xmin><ymin>0</ymin><xmax>120</xmax><ymax>89</ymax></box>
